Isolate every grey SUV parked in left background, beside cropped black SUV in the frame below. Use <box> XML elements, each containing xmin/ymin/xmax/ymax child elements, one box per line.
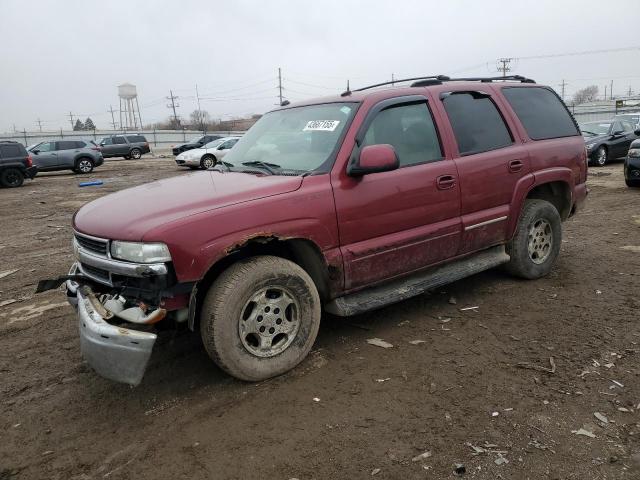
<box><xmin>29</xmin><ymin>140</ymin><xmax>104</xmax><ymax>173</ymax></box>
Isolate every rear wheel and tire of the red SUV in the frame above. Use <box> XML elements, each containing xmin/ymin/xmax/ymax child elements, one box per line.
<box><xmin>506</xmin><ymin>200</ymin><xmax>562</xmax><ymax>279</ymax></box>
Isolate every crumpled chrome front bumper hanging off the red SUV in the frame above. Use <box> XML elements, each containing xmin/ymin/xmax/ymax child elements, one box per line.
<box><xmin>67</xmin><ymin>274</ymin><xmax>157</xmax><ymax>385</ymax></box>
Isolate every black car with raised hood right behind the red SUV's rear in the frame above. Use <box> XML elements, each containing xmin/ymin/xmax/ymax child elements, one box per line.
<box><xmin>579</xmin><ymin>120</ymin><xmax>637</xmax><ymax>167</ymax></box>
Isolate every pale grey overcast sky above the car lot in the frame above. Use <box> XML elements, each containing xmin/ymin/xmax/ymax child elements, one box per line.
<box><xmin>0</xmin><ymin>0</ymin><xmax>640</xmax><ymax>131</ymax></box>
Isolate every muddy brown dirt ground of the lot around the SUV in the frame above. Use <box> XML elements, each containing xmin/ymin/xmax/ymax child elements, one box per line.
<box><xmin>0</xmin><ymin>158</ymin><xmax>640</xmax><ymax>480</ymax></box>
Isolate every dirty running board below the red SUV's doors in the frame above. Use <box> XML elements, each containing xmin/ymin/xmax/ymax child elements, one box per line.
<box><xmin>325</xmin><ymin>245</ymin><xmax>510</xmax><ymax>317</ymax></box>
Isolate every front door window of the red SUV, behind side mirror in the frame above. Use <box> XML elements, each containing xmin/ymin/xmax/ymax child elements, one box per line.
<box><xmin>362</xmin><ymin>103</ymin><xmax>442</xmax><ymax>166</ymax></box>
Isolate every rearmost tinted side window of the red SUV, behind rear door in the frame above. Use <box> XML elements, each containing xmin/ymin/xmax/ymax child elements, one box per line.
<box><xmin>502</xmin><ymin>87</ymin><xmax>580</xmax><ymax>140</ymax></box>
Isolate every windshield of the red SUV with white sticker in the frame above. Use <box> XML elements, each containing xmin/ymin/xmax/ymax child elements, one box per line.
<box><xmin>224</xmin><ymin>103</ymin><xmax>356</xmax><ymax>174</ymax></box>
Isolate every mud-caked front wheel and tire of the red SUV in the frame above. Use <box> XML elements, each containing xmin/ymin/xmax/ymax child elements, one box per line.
<box><xmin>200</xmin><ymin>256</ymin><xmax>321</xmax><ymax>381</ymax></box>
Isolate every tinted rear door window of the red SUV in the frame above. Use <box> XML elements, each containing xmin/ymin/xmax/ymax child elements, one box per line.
<box><xmin>443</xmin><ymin>92</ymin><xmax>513</xmax><ymax>155</ymax></box>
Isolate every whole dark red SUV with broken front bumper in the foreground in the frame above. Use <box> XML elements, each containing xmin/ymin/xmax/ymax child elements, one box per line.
<box><xmin>40</xmin><ymin>76</ymin><xmax>587</xmax><ymax>384</ymax></box>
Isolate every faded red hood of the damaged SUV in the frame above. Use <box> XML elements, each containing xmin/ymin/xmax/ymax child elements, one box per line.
<box><xmin>73</xmin><ymin>171</ymin><xmax>303</xmax><ymax>241</ymax></box>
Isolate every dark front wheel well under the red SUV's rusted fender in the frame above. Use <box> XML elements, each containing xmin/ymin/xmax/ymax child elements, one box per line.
<box><xmin>190</xmin><ymin>235</ymin><xmax>329</xmax><ymax>330</ymax></box>
